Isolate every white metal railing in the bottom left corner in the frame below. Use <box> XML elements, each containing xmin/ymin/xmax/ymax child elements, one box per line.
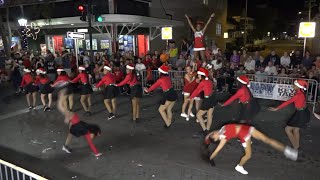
<box><xmin>0</xmin><ymin>159</ymin><xmax>48</xmax><ymax>180</ymax></box>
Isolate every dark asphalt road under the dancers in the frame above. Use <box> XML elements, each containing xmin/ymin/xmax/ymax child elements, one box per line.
<box><xmin>0</xmin><ymin>87</ymin><xmax>320</xmax><ymax>180</ymax></box>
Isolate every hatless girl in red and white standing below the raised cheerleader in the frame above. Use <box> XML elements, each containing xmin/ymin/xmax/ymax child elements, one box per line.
<box><xmin>181</xmin><ymin>66</ymin><xmax>200</xmax><ymax>121</ymax></box>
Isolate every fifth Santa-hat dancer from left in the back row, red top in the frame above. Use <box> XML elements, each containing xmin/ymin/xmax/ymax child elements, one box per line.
<box><xmin>96</xmin><ymin>66</ymin><xmax>120</xmax><ymax>120</ymax></box>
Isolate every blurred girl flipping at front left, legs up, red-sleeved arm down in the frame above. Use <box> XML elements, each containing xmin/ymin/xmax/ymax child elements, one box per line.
<box><xmin>57</xmin><ymin>89</ymin><xmax>102</xmax><ymax>157</ymax></box>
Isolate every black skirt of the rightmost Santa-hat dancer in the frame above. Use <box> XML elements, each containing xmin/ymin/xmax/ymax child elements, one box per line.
<box><xmin>287</xmin><ymin>108</ymin><xmax>310</xmax><ymax>128</ymax></box>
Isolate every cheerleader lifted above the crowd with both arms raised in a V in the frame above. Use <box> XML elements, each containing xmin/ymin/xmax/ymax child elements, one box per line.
<box><xmin>185</xmin><ymin>13</ymin><xmax>215</xmax><ymax>61</ymax></box>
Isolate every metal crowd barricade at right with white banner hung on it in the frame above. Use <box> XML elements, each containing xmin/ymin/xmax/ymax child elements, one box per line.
<box><xmin>247</xmin><ymin>74</ymin><xmax>318</xmax><ymax>112</ymax></box>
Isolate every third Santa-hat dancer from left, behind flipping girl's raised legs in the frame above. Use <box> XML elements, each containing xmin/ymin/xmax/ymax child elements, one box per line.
<box><xmin>53</xmin><ymin>67</ymin><xmax>74</xmax><ymax>112</ymax></box>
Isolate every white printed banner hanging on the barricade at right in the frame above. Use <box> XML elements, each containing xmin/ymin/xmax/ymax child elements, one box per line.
<box><xmin>250</xmin><ymin>81</ymin><xmax>295</xmax><ymax>101</ymax></box>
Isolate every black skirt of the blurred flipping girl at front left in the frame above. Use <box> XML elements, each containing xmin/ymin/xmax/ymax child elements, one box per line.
<box><xmin>70</xmin><ymin>121</ymin><xmax>101</xmax><ymax>137</ymax></box>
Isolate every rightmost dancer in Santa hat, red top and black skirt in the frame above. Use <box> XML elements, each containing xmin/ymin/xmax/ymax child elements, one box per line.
<box><xmin>269</xmin><ymin>80</ymin><xmax>310</xmax><ymax>150</ymax></box>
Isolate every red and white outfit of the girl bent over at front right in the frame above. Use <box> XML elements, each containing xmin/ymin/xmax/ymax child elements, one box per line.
<box><xmin>219</xmin><ymin>124</ymin><xmax>253</xmax><ymax>146</ymax></box>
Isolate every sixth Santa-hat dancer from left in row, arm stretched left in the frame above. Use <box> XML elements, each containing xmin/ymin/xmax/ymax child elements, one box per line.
<box><xmin>116</xmin><ymin>64</ymin><xmax>142</xmax><ymax>123</ymax></box>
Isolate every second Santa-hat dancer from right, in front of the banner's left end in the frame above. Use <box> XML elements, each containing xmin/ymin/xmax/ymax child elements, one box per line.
<box><xmin>222</xmin><ymin>75</ymin><xmax>260</xmax><ymax>123</ymax></box>
